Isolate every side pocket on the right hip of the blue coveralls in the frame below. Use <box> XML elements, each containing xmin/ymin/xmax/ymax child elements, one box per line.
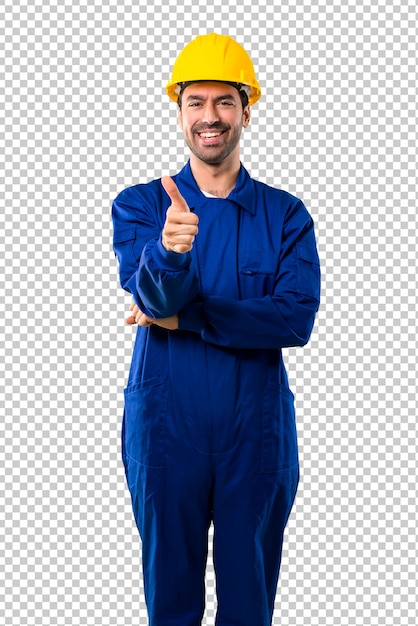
<box><xmin>261</xmin><ymin>383</ymin><xmax>299</xmax><ymax>474</ymax></box>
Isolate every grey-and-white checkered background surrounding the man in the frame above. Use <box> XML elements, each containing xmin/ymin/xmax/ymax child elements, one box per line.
<box><xmin>0</xmin><ymin>0</ymin><xmax>418</xmax><ymax>626</ymax></box>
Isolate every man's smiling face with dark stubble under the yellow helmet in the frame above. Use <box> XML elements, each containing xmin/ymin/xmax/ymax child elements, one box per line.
<box><xmin>178</xmin><ymin>82</ymin><xmax>250</xmax><ymax>165</ymax></box>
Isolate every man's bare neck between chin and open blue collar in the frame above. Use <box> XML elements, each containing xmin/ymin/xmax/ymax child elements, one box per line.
<box><xmin>190</xmin><ymin>154</ymin><xmax>241</xmax><ymax>198</ymax></box>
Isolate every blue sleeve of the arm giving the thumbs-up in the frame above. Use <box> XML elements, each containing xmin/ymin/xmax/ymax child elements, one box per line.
<box><xmin>112</xmin><ymin>185</ymin><xmax>198</xmax><ymax>319</ymax></box>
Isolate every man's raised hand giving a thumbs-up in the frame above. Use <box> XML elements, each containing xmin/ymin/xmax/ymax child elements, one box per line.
<box><xmin>161</xmin><ymin>176</ymin><xmax>199</xmax><ymax>254</ymax></box>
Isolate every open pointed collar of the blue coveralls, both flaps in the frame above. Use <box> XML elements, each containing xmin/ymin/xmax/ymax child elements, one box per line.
<box><xmin>175</xmin><ymin>161</ymin><xmax>255</xmax><ymax>214</ymax></box>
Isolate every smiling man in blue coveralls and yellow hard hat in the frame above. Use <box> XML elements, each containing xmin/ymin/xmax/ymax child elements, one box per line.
<box><xmin>113</xmin><ymin>33</ymin><xmax>319</xmax><ymax>626</ymax></box>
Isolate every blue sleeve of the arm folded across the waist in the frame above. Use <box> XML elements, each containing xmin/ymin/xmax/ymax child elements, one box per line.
<box><xmin>180</xmin><ymin>201</ymin><xmax>320</xmax><ymax>349</ymax></box>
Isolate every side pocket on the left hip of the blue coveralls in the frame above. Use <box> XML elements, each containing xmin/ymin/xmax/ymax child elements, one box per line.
<box><xmin>123</xmin><ymin>378</ymin><xmax>167</xmax><ymax>468</ymax></box>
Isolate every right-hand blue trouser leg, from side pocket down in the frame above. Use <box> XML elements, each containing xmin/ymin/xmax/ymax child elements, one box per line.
<box><xmin>209</xmin><ymin>383</ymin><xmax>299</xmax><ymax>626</ymax></box>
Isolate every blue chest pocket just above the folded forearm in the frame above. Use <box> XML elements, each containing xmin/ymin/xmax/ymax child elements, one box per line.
<box><xmin>239</xmin><ymin>249</ymin><xmax>277</xmax><ymax>300</ymax></box>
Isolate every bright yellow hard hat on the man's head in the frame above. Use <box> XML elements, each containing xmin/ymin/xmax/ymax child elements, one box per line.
<box><xmin>166</xmin><ymin>33</ymin><xmax>261</xmax><ymax>105</ymax></box>
